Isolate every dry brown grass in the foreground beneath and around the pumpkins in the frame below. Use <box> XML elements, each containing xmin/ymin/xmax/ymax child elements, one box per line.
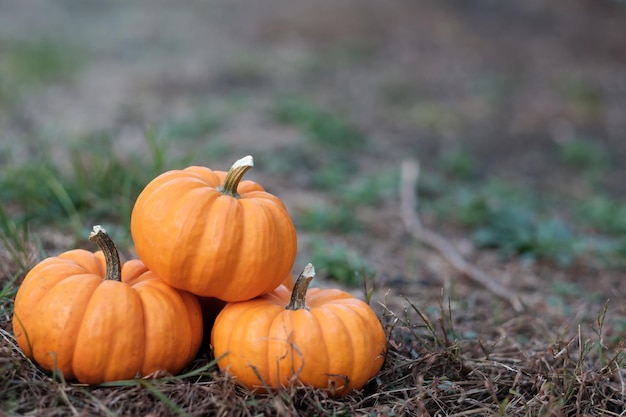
<box><xmin>0</xmin><ymin>280</ymin><xmax>626</xmax><ymax>417</ymax></box>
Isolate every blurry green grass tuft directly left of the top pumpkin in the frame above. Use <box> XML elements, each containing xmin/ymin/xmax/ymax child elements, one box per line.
<box><xmin>0</xmin><ymin>133</ymin><xmax>171</xmax><ymax>244</ymax></box>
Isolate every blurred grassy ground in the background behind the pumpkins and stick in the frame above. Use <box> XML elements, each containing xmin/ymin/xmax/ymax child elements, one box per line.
<box><xmin>0</xmin><ymin>0</ymin><xmax>626</xmax><ymax>300</ymax></box>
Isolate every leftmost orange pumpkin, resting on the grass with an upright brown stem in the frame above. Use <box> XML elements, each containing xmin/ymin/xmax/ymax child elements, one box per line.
<box><xmin>13</xmin><ymin>226</ymin><xmax>202</xmax><ymax>384</ymax></box>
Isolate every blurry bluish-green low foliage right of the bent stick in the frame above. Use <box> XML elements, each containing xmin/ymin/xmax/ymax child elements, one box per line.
<box><xmin>418</xmin><ymin>148</ymin><xmax>626</xmax><ymax>266</ymax></box>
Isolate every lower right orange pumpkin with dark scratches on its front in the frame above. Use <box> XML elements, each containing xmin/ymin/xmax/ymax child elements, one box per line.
<box><xmin>211</xmin><ymin>264</ymin><xmax>386</xmax><ymax>395</ymax></box>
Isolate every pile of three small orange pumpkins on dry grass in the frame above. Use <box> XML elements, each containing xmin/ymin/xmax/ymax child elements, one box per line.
<box><xmin>13</xmin><ymin>156</ymin><xmax>386</xmax><ymax>395</ymax></box>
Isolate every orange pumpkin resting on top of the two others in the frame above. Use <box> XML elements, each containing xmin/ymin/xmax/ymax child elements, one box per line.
<box><xmin>131</xmin><ymin>156</ymin><xmax>297</xmax><ymax>301</ymax></box>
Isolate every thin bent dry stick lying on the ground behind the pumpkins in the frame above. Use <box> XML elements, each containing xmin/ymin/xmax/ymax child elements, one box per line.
<box><xmin>400</xmin><ymin>160</ymin><xmax>525</xmax><ymax>313</ymax></box>
